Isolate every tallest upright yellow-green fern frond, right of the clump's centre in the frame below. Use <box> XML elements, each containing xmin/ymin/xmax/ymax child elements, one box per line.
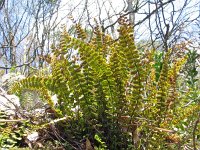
<box><xmin>118</xmin><ymin>20</ymin><xmax>143</xmax><ymax>119</ymax></box>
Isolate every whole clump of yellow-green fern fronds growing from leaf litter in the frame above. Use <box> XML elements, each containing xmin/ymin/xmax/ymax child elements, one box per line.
<box><xmin>11</xmin><ymin>18</ymin><xmax>199</xmax><ymax>149</ymax></box>
